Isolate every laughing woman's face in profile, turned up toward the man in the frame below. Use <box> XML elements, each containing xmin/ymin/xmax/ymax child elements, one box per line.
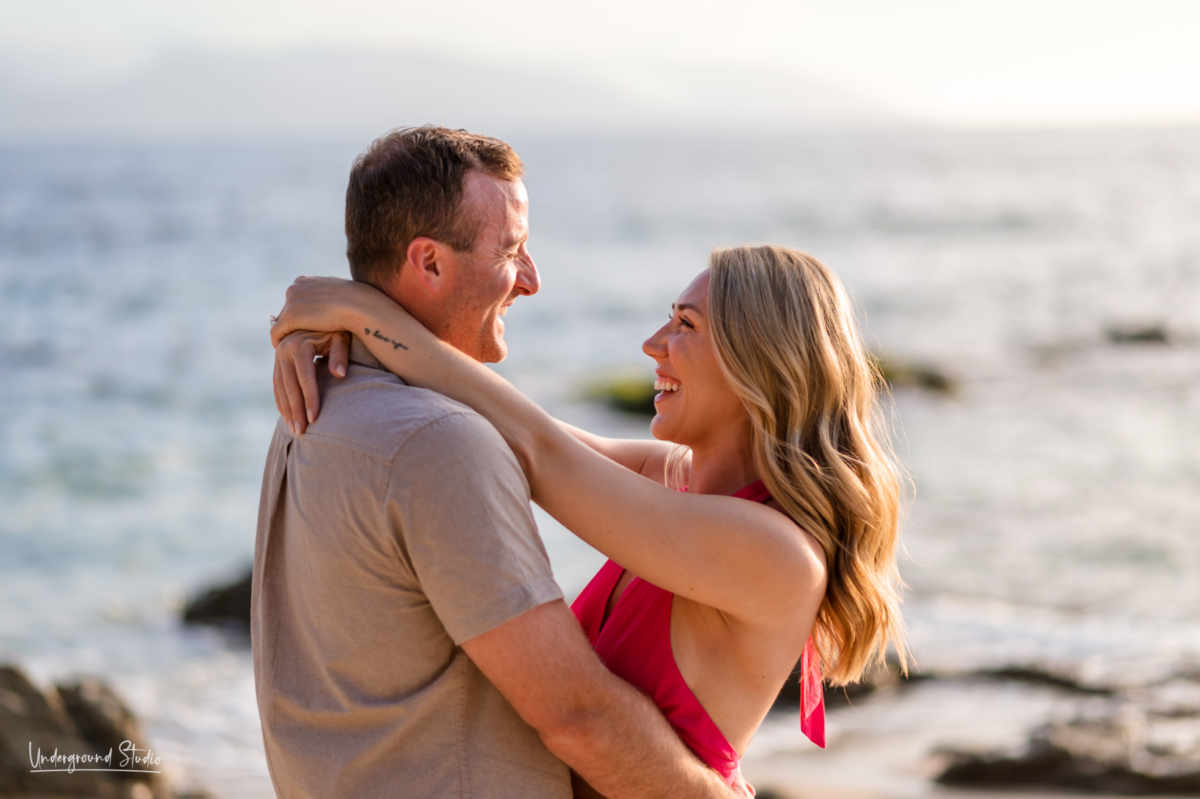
<box><xmin>642</xmin><ymin>269</ymin><xmax>749</xmax><ymax>450</ymax></box>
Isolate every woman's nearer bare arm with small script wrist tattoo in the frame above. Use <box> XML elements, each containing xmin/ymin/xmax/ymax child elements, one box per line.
<box><xmin>271</xmin><ymin>278</ymin><xmax>824</xmax><ymax>623</ymax></box>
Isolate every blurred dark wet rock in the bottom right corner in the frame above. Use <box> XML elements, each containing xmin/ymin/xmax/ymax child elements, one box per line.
<box><xmin>937</xmin><ymin>679</ymin><xmax>1200</xmax><ymax>795</ymax></box>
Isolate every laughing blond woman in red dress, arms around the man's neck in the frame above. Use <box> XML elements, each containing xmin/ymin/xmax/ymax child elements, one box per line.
<box><xmin>272</xmin><ymin>246</ymin><xmax>904</xmax><ymax>783</ymax></box>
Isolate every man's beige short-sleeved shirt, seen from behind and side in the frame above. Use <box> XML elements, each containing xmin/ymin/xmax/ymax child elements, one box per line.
<box><xmin>251</xmin><ymin>342</ymin><xmax>571</xmax><ymax>799</ymax></box>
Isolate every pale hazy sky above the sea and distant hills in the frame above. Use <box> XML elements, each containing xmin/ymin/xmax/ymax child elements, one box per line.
<box><xmin>0</xmin><ymin>0</ymin><xmax>1200</xmax><ymax>136</ymax></box>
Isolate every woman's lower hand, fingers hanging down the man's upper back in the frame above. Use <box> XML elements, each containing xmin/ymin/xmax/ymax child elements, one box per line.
<box><xmin>274</xmin><ymin>330</ymin><xmax>350</xmax><ymax>434</ymax></box>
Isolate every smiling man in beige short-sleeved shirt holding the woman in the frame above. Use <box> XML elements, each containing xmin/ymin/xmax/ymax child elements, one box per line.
<box><xmin>252</xmin><ymin>127</ymin><xmax>733</xmax><ymax>799</ymax></box>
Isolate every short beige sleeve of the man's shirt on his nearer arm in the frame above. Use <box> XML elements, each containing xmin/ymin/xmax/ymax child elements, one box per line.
<box><xmin>386</xmin><ymin>411</ymin><xmax>563</xmax><ymax>644</ymax></box>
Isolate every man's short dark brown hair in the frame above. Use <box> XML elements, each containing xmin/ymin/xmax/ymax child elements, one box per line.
<box><xmin>346</xmin><ymin>125</ymin><xmax>524</xmax><ymax>288</ymax></box>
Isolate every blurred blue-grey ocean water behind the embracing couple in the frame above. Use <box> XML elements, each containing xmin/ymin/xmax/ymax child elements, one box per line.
<box><xmin>0</xmin><ymin>130</ymin><xmax>1200</xmax><ymax>797</ymax></box>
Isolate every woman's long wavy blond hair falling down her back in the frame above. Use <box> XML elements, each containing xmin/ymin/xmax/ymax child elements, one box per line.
<box><xmin>681</xmin><ymin>245</ymin><xmax>907</xmax><ymax>685</ymax></box>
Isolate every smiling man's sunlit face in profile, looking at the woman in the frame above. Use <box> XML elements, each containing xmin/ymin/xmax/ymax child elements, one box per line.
<box><xmin>439</xmin><ymin>172</ymin><xmax>541</xmax><ymax>364</ymax></box>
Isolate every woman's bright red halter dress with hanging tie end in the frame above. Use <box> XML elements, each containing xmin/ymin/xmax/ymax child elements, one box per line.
<box><xmin>571</xmin><ymin>480</ymin><xmax>824</xmax><ymax>785</ymax></box>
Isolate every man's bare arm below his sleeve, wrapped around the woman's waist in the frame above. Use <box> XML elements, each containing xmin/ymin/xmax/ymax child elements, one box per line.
<box><xmin>462</xmin><ymin>600</ymin><xmax>736</xmax><ymax>799</ymax></box>
